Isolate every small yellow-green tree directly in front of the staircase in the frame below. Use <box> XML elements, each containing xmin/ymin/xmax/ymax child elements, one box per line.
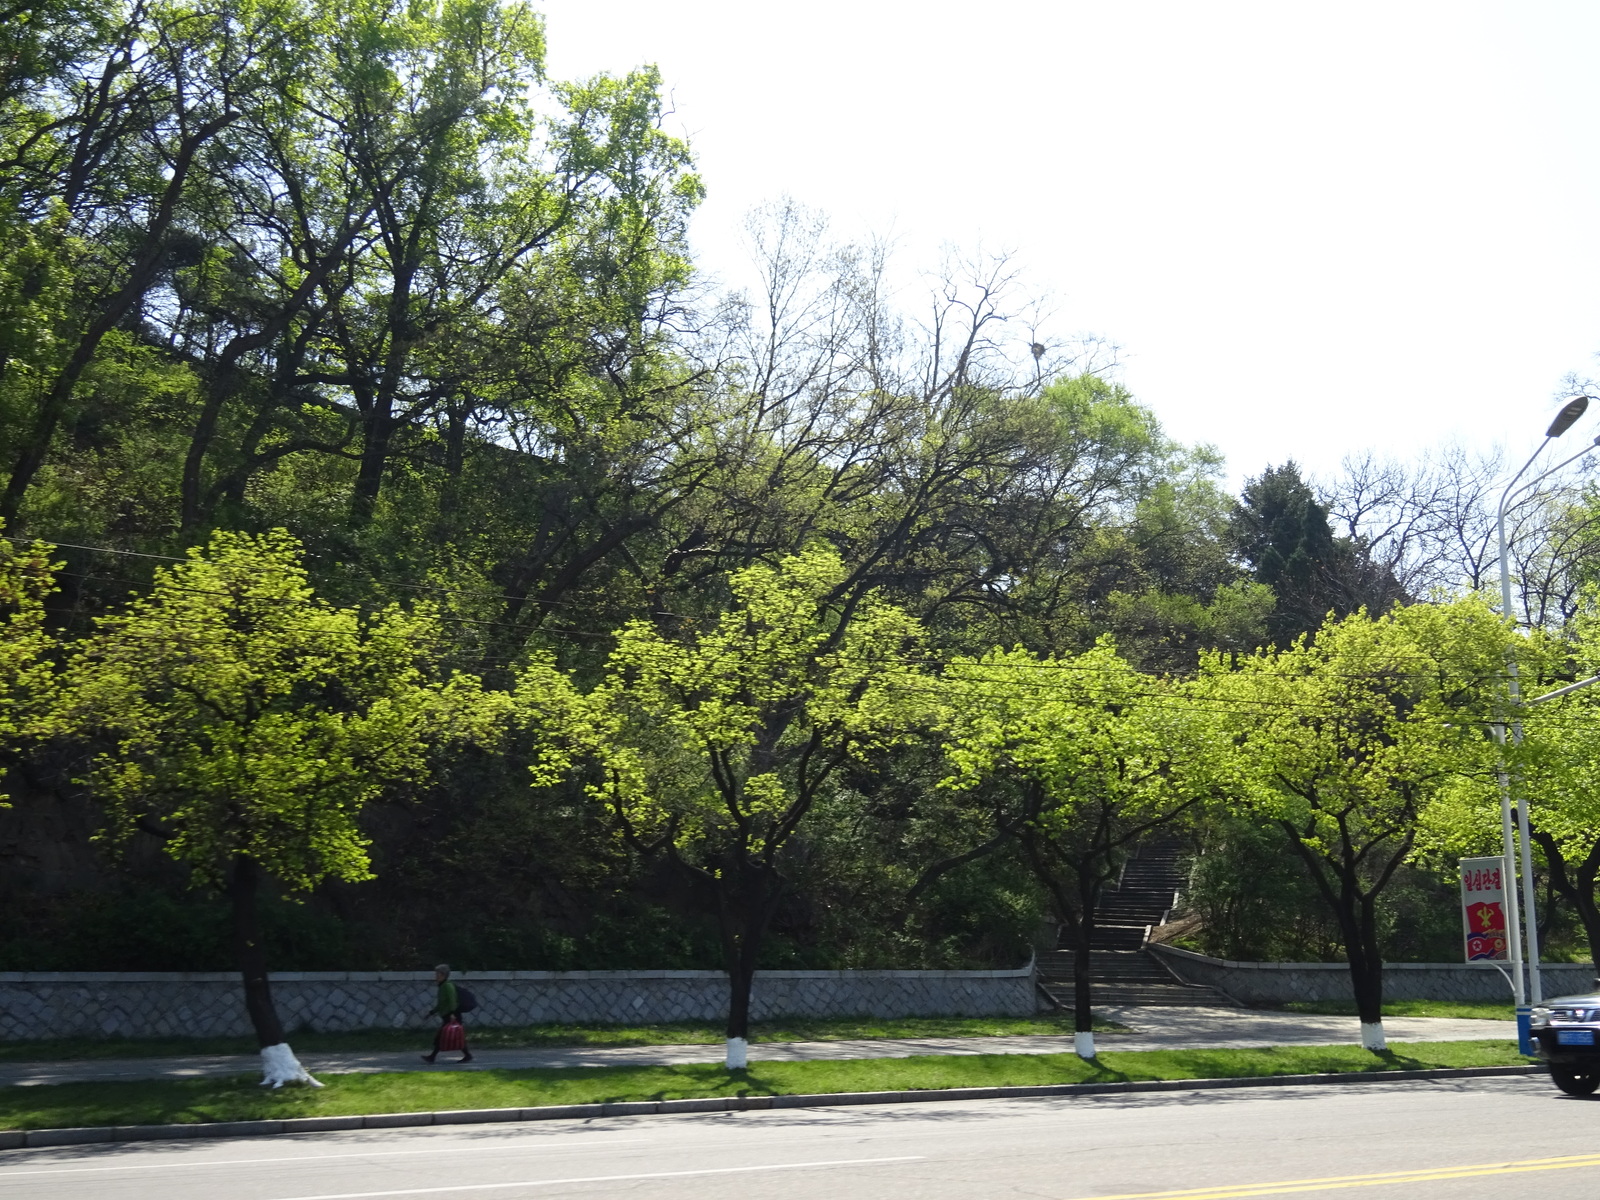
<box><xmin>944</xmin><ymin>637</ymin><xmax>1211</xmax><ymax>1058</ymax></box>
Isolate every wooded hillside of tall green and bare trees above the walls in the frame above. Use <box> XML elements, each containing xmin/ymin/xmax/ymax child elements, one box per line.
<box><xmin>0</xmin><ymin>0</ymin><xmax>1600</xmax><ymax>1062</ymax></box>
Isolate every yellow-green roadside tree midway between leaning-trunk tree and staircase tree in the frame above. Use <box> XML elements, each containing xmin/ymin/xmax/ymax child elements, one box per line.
<box><xmin>579</xmin><ymin>549</ymin><xmax>930</xmax><ymax>1069</ymax></box>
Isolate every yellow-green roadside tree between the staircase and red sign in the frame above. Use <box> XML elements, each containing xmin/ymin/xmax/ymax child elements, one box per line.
<box><xmin>1205</xmin><ymin>598</ymin><xmax>1507</xmax><ymax>1050</ymax></box>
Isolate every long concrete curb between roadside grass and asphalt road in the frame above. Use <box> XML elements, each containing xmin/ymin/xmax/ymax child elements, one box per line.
<box><xmin>0</xmin><ymin>1066</ymin><xmax>1546</xmax><ymax>1150</ymax></box>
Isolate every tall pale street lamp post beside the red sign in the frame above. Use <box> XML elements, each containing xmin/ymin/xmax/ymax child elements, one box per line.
<box><xmin>1494</xmin><ymin>395</ymin><xmax>1600</xmax><ymax>1054</ymax></box>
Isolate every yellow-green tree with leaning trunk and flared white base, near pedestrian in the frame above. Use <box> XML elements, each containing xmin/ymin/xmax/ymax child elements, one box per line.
<box><xmin>62</xmin><ymin>531</ymin><xmax>506</xmax><ymax>1086</ymax></box>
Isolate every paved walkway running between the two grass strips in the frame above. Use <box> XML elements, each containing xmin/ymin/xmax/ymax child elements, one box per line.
<box><xmin>0</xmin><ymin>1006</ymin><xmax>1517</xmax><ymax>1085</ymax></box>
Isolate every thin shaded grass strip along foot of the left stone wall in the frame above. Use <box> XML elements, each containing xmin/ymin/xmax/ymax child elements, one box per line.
<box><xmin>0</xmin><ymin>1013</ymin><xmax>1130</xmax><ymax>1062</ymax></box>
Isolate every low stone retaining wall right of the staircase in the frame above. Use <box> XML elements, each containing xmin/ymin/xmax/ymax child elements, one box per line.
<box><xmin>1150</xmin><ymin>944</ymin><xmax>1595</xmax><ymax>1005</ymax></box>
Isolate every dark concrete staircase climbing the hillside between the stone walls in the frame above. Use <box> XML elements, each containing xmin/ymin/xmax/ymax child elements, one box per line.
<box><xmin>1038</xmin><ymin>840</ymin><xmax>1237</xmax><ymax>1008</ymax></box>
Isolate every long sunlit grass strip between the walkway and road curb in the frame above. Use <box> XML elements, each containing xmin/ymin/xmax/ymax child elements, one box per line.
<box><xmin>0</xmin><ymin>1042</ymin><xmax>1528</xmax><ymax>1130</ymax></box>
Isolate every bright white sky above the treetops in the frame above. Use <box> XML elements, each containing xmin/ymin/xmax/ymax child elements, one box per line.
<box><xmin>544</xmin><ymin>0</ymin><xmax>1600</xmax><ymax>485</ymax></box>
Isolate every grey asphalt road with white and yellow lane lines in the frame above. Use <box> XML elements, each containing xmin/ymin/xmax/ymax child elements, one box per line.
<box><xmin>0</xmin><ymin>1077</ymin><xmax>1600</xmax><ymax>1200</ymax></box>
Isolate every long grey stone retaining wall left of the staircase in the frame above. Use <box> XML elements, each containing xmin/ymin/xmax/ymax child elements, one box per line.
<box><xmin>0</xmin><ymin>963</ymin><xmax>1037</xmax><ymax>1042</ymax></box>
